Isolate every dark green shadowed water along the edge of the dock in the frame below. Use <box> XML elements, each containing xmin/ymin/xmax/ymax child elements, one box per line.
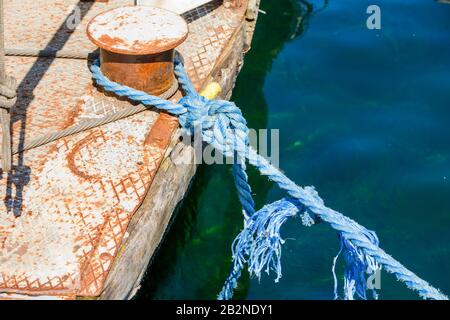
<box><xmin>136</xmin><ymin>0</ymin><xmax>320</xmax><ymax>299</ymax></box>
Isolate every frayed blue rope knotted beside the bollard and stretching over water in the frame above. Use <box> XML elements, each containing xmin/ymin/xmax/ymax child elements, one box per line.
<box><xmin>91</xmin><ymin>59</ymin><xmax>448</xmax><ymax>300</ymax></box>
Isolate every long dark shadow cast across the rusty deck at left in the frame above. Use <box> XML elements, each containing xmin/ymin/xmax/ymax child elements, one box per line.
<box><xmin>4</xmin><ymin>1</ymin><xmax>93</xmax><ymax>217</ymax></box>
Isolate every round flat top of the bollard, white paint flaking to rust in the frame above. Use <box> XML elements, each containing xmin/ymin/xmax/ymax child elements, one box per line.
<box><xmin>87</xmin><ymin>6</ymin><xmax>188</xmax><ymax>55</ymax></box>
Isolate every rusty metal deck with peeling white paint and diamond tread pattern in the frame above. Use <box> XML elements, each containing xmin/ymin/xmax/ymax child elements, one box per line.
<box><xmin>0</xmin><ymin>0</ymin><xmax>244</xmax><ymax>297</ymax></box>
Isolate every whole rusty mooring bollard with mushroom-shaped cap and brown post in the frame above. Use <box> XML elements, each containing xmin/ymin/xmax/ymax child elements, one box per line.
<box><xmin>87</xmin><ymin>6</ymin><xmax>188</xmax><ymax>96</ymax></box>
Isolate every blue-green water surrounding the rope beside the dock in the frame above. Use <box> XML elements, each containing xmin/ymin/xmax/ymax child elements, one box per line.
<box><xmin>137</xmin><ymin>0</ymin><xmax>450</xmax><ymax>299</ymax></box>
